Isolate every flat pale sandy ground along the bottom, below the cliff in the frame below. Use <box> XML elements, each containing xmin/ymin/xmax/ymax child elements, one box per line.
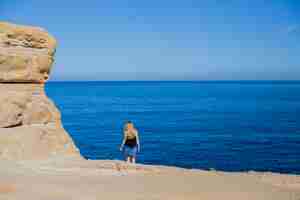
<box><xmin>0</xmin><ymin>158</ymin><xmax>300</xmax><ymax>200</ymax></box>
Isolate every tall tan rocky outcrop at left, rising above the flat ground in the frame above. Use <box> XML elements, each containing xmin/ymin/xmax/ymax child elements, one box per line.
<box><xmin>0</xmin><ymin>22</ymin><xmax>80</xmax><ymax>160</ymax></box>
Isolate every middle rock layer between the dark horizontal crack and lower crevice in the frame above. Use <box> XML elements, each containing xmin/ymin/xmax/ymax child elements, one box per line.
<box><xmin>0</xmin><ymin>83</ymin><xmax>60</xmax><ymax>128</ymax></box>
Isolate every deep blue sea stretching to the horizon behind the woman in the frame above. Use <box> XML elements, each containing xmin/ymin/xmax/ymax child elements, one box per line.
<box><xmin>46</xmin><ymin>81</ymin><xmax>300</xmax><ymax>174</ymax></box>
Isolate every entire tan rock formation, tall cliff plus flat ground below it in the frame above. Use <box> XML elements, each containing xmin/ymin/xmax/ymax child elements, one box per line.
<box><xmin>0</xmin><ymin>22</ymin><xmax>300</xmax><ymax>200</ymax></box>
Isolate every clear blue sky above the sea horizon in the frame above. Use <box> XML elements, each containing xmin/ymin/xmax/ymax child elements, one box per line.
<box><xmin>0</xmin><ymin>0</ymin><xmax>300</xmax><ymax>80</ymax></box>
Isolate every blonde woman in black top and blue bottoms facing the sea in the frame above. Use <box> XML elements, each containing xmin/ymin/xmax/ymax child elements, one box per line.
<box><xmin>120</xmin><ymin>121</ymin><xmax>140</xmax><ymax>163</ymax></box>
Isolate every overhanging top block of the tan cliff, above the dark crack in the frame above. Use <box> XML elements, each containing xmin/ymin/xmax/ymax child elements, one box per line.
<box><xmin>0</xmin><ymin>22</ymin><xmax>56</xmax><ymax>82</ymax></box>
